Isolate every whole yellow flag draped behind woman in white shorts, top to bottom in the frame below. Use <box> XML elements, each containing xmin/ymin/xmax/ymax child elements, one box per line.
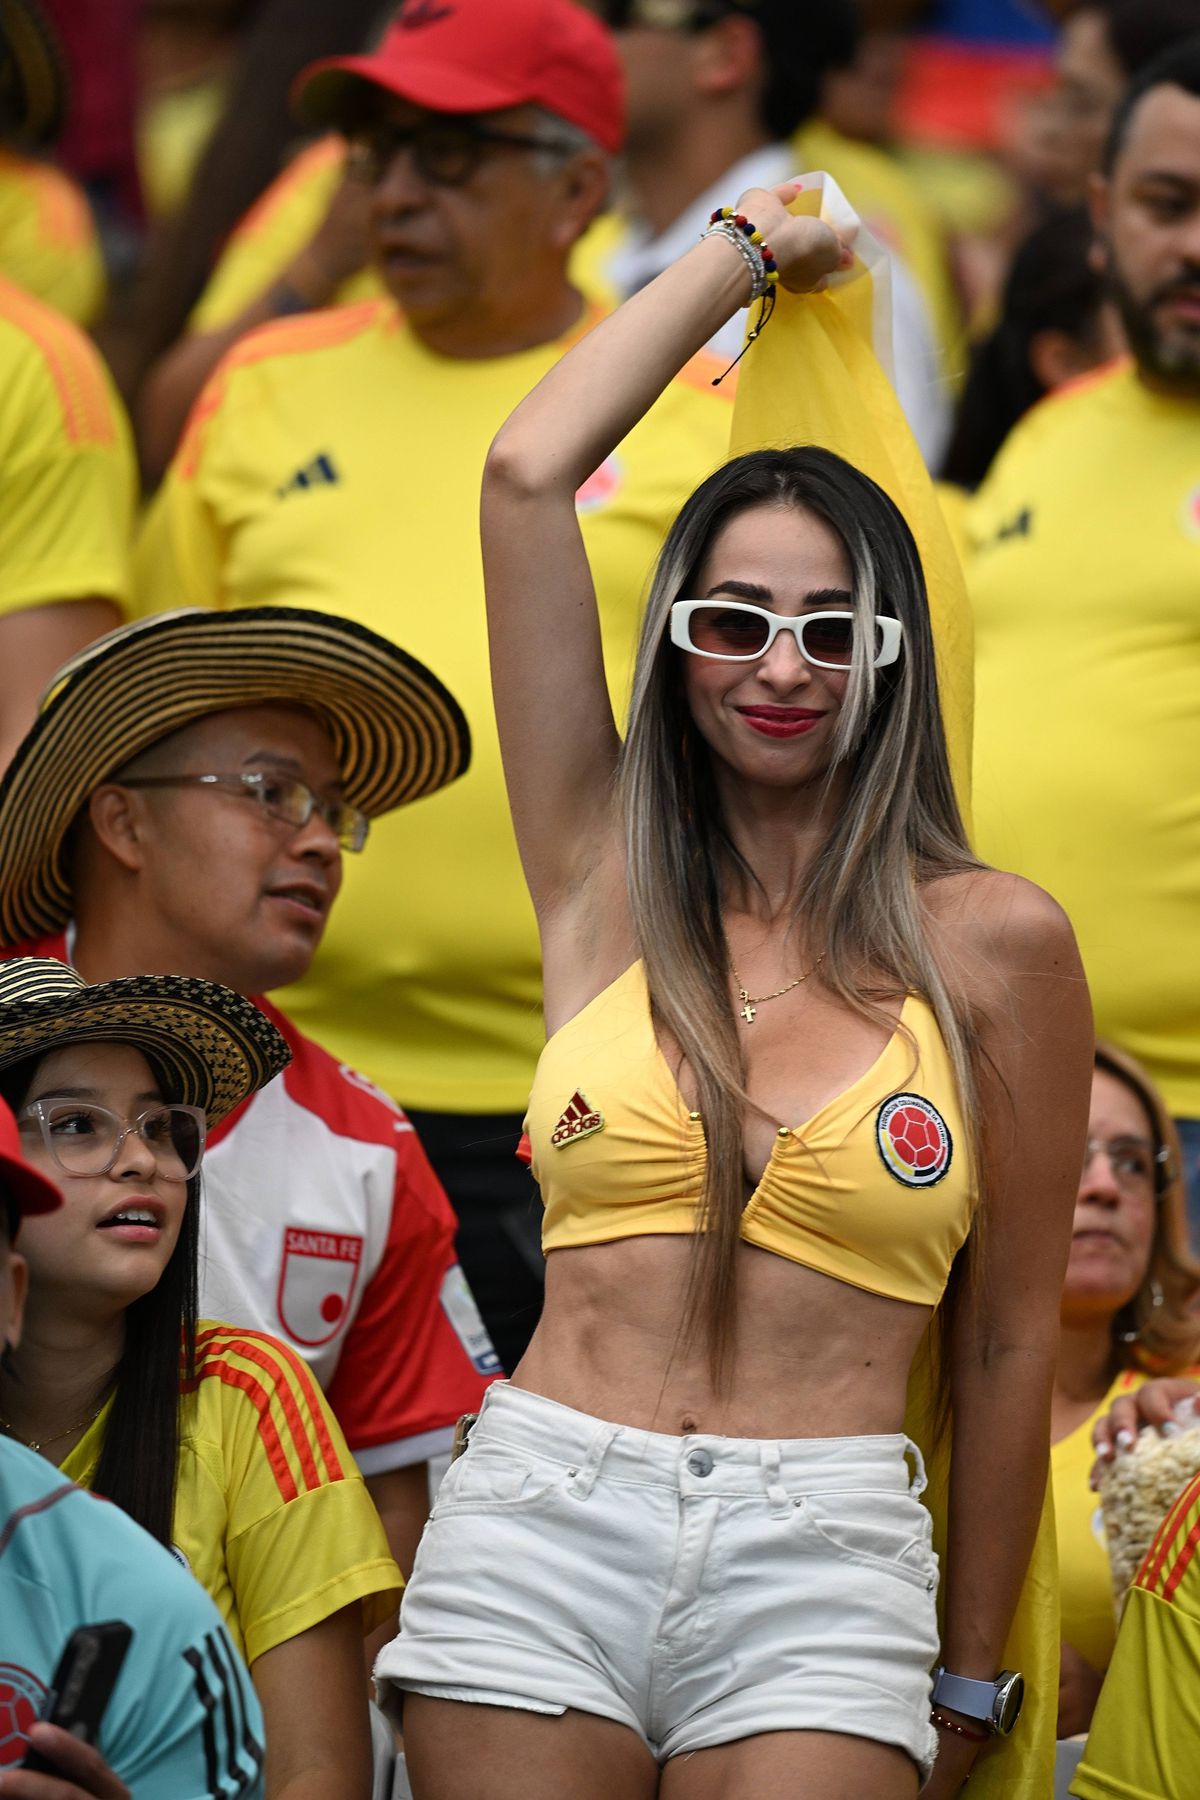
<box><xmin>730</xmin><ymin>175</ymin><xmax>1060</xmax><ymax>1800</ymax></box>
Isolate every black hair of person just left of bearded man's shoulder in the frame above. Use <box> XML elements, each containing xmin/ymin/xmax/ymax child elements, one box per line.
<box><xmin>941</xmin><ymin>207</ymin><xmax>1105</xmax><ymax>488</ymax></box>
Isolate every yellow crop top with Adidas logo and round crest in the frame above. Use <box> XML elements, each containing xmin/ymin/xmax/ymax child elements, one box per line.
<box><xmin>525</xmin><ymin>963</ymin><xmax>975</xmax><ymax>1307</ymax></box>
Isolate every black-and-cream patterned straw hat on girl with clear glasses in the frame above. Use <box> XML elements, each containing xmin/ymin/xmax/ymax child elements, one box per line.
<box><xmin>0</xmin><ymin>956</ymin><xmax>291</xmax><ymax>1125</ymax></box>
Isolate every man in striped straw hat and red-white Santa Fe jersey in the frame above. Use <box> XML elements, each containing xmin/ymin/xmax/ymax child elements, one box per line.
<box><xmin>0</xmin><ymin>607</ymin><xmax>498</xmax><ymax>1568</ymax></box>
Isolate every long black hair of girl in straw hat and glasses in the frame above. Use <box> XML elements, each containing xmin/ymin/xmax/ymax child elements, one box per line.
<box><xmin>0</xmin><ymin>1057</ymin><xmax>200</xmax><ymax>1544</ymax></box>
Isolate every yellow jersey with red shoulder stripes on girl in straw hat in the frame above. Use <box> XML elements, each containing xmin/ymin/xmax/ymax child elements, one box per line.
<box><xmin>61</xmin><ymin>1319</ymin><xmax>403</xmax><ymax>1663</ymax></box>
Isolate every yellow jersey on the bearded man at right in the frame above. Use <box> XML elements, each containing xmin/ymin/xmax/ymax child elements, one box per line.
<box><xmin>966</xmin><ymin>362</ymin><xmax>1200</xmax><ymax>1118</ymax></box>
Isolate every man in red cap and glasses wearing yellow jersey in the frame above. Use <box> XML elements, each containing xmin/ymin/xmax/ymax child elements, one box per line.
<box><xmin>137</xmin><ymin>0</ymin><xmax>730</xmax><ymax>1370</ymax></box>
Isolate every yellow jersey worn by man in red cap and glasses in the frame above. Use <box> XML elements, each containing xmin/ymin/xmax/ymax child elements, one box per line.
<box><xmin>135</xmin><ymin>301</ymin><xmax>732</xmax><ymax>1112</ymax></box>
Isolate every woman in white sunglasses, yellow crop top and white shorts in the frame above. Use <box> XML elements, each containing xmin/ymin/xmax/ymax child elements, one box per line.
<box><xmin>376</xmin><ymin>189</ymin><xmax>1092</xmax><ymax>1800</ymax></box>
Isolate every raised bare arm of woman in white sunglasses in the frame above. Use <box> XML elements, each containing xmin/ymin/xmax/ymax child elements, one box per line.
<box><xmin>482</xmin><ymin>187</ymin><xmax>849</xmax><ymax>925</ymax></box>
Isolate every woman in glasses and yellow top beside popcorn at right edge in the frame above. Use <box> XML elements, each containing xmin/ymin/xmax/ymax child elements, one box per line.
<box><xmin>1051</xmin><ymin>1044</ymin><xmax>1200</xmax><ymax>1737</ymax></box>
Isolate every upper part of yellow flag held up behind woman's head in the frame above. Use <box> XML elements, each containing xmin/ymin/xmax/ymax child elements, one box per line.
<box><xmin>730</xmin><ymin>175</ymin><xmax>975</xmax><ymax>819</ymax></box>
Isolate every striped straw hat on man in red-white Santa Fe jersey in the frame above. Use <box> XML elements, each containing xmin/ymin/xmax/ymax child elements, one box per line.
<box><xmin>0</xmin><ymin>607</ymin><xmax>471</xmax><ymax>943</ymax></box>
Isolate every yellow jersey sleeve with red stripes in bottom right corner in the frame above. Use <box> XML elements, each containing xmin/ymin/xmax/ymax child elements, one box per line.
<box><xmin>1070</xmin><ymin>1476</ymin><xmax>1200</xmax><ymax>1800</ymax></box>
